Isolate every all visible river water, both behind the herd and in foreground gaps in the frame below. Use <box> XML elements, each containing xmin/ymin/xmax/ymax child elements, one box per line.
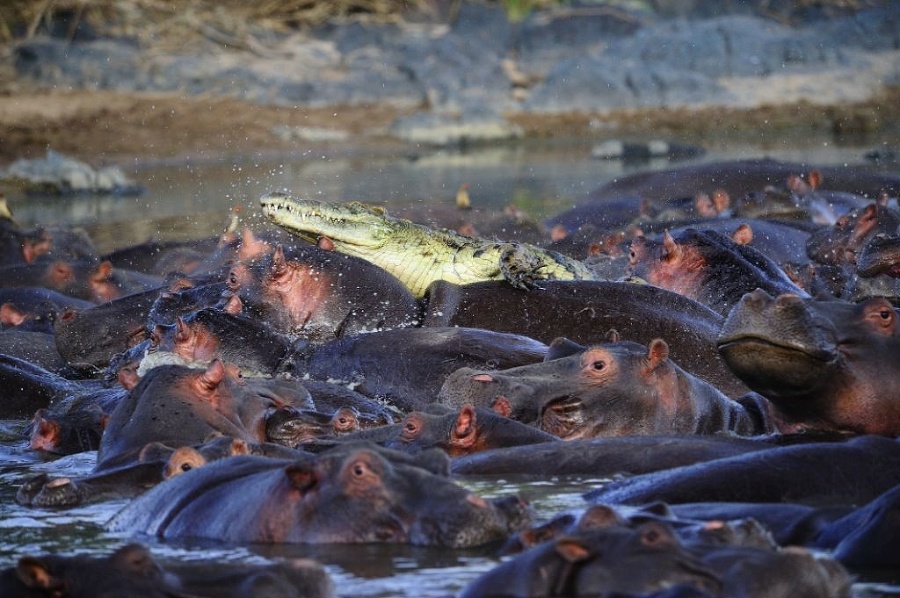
<box><xmin>0</xmin><ymin>134</ymin><xmax>900</xmax><ymax>597</ymax></box>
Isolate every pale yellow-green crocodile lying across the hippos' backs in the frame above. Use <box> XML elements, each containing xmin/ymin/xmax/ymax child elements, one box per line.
<box><xmin>260</xmin><ymin>192</ymin><xmax>596</xmax><ymax>297</ymax></box>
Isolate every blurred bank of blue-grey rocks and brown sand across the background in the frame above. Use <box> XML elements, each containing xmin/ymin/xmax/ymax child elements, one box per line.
<box><xmin>0</xmin><ymin>1</ymin><xmax>900</xmax><ymax>162</ymax></box>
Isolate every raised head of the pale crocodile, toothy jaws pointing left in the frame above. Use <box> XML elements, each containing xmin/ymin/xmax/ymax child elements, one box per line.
<box><xmin>259</xmin><ymin>192</ymin><xmax>397</xmax><ymax>254</ymax></box>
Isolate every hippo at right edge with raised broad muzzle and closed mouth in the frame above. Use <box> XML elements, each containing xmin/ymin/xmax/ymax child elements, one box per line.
<box><xmin>718</xmin><ymin>290</ymin><xmax>900</xmax><ymax>436</ymax></box>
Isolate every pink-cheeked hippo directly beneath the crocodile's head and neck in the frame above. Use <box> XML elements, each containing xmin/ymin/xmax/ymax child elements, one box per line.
<box><xmin>228</xmin><ymin>245</ymin><xmax>421</xmax><ymax>343</ymax></box>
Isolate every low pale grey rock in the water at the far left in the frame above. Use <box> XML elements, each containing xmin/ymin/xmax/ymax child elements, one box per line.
<box><xmin>0</xmin><ymin>150</ymin><xmax>143</xmax><ymax>195</ymax></box>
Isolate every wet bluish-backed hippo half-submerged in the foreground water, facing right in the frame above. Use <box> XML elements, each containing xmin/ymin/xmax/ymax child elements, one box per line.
<box><xmin>108</xmin><ymin>443</ymin><xmax>529</xmax><ymax>548</ymax></box>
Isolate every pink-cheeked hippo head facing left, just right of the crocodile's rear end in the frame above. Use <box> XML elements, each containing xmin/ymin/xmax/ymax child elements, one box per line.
<box><xmin>628</xmin><ymin>228</ymin><xmax>807</xmax><ymax>316</ymax></box>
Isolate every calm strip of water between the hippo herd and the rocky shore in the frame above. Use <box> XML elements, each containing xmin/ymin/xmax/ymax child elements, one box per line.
<box><xmin>9</xmin><ymin>132</ymin><xmax>896</xmax><ymax>251</ymax></box>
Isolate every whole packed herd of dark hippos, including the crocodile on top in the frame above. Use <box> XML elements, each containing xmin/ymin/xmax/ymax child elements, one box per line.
<box><xmin>0</xmin><ymin>160</ymin><xmax>900</xmax><ymax>598</ymax></box>
